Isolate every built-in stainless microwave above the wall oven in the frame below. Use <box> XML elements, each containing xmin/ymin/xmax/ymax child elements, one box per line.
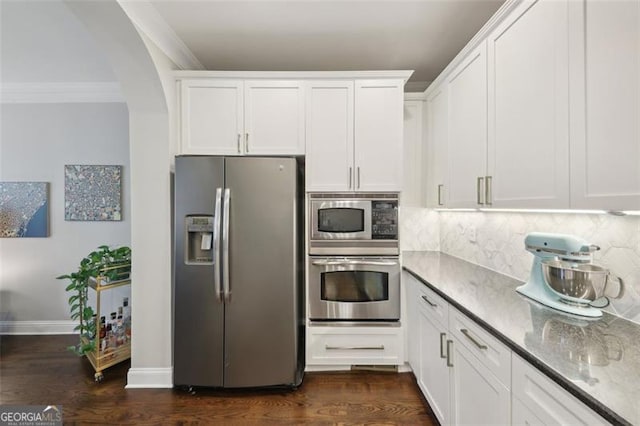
<box><xmin>309</xmin><ymin>193</ymin><xmax>399</xmax><ymax>255</ymax></box>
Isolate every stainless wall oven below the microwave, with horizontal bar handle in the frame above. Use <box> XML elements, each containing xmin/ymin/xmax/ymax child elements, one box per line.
<box><xmin>309</xmin><ymin>256</ymin><xmax>400</xmax><ymax>321</ymax></box>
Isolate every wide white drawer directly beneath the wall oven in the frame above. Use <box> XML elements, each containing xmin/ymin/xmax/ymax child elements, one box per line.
<box><xmin>306</xmin><ymin>326</ymin><xmax>404</xmax><ymax>365</ymax></box>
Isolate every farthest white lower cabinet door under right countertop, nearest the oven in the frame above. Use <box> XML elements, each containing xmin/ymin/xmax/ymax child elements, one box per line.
<box><xmin>417</xmin><ymin>309</ymin><xmax>451</xmax><ymax>424</ymax></box>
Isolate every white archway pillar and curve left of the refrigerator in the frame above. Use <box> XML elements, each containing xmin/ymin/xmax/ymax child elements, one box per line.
<box><xmin>65</xmin><ymin>0</ymin><xmax>173</xmax><ymax>388</ymax></box>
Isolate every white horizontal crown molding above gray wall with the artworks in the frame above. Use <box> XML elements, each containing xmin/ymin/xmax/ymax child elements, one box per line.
<box><xmin>0</xmin><ymin>82</ymin><xmax>126</xmax><ymax>104</ymax></box>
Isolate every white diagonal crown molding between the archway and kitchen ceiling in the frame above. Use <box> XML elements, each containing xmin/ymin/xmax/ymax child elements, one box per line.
<box><xmin>118</xmin><ymin>0</ymin><xmax>204</xmax><ymax>70</ymax></box>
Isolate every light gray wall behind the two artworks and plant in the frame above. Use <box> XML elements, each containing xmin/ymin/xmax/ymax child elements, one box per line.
<box><xmin>0</xmin><ymin>103</ymin><xmax>131</xmax><ymax>333</ymax></box>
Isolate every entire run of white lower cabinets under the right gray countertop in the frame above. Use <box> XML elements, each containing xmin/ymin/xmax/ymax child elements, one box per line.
<box><xmin>402</xmin><ymin>272</ymin><xmax>609</xmax><ymax>425</ymax></box>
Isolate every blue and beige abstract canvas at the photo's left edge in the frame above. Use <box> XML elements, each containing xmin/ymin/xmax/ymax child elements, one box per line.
<box><xmin>0</xmin><ymin>182</ymin><xmax>49</xmax><ymax>238</ymax></box>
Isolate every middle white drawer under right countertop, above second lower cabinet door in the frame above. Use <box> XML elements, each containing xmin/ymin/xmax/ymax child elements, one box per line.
<box><xmin>449</xmin><ymin>308</ymin><xmax>511</xmax><ymax>388</ymax></box>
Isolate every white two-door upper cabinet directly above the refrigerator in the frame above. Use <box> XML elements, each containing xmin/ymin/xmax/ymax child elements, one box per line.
<box><xmin>180</xmin><ymin>78</ymin><xmax>305</xmax><ymax>155</ymax></box>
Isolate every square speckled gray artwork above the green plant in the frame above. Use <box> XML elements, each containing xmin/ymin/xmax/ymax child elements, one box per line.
<box><xmin>64</xmin><ymin>165</ymin><xmax>122</xmax><ymax>221</ymax></box>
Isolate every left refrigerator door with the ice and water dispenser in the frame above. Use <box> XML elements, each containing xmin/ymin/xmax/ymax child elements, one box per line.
<box><xmin>173</xmin><ymin>156</ymin><xmax>224</xmax><ymax>386</ymax></box>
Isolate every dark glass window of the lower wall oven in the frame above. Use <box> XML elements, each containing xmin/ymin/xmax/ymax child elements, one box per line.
<box><xmin>320</xmin><ymin>271</ymin><xmax>389</xmax><ymax>302</ymax></box>
